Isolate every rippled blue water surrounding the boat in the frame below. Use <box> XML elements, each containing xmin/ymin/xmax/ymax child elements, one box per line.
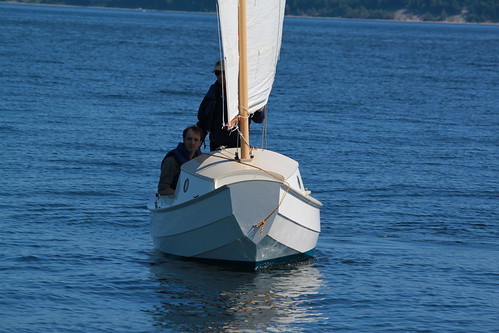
<box><xmin>0</xmin><ymin>4</ymin><xmax>499</xmax><ymax>333</ymax></box>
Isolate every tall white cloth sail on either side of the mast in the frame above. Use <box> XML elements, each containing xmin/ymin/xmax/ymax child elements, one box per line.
<box><xmin>218</xmin><ymin>0</ymin><xmax>286</xmax><ymax>121</ymax></box>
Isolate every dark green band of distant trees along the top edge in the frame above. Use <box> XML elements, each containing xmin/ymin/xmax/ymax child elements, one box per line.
<box><xmin>4</xmin><ymin>0</ymin><xmax>499</xmax><ymax>23</ymax></box>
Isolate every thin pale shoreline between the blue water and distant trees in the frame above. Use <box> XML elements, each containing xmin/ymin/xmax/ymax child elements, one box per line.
<box><xmin>0</xmin><ymin>1</ymin><xmax>499</xmax><ymax>25</ymax></box>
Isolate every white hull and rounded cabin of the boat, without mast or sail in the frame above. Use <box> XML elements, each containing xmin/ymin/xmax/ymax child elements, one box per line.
<box><xmin>149</xmin><ymin>149</ymin><xmax>321</xmax><ymax>266</ymax></box>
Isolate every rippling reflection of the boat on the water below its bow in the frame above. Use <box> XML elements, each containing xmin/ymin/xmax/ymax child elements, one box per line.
<box><xmin>147</xmin><ymin>253</ymin><xmax>327</xmax><ymax>332</ymax></box>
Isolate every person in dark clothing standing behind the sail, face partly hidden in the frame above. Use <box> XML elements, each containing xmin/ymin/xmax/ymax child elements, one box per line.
<box><xmin>197</xmin><ymin>60</ymin><xmax>267</xmax><ymax>151</ymax></box>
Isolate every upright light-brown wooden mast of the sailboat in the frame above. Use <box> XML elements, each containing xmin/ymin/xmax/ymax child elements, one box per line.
<box><xmin>239</xmin><ymin>0</ymin><xmax>250</xmax><ymax>160</ymax></box>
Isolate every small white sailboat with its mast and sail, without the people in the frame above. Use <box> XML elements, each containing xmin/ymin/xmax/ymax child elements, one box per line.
<box><xmin>148</xmin><ymin>0</ymin><xmax>322</xmax><ymax>268</ymax></box>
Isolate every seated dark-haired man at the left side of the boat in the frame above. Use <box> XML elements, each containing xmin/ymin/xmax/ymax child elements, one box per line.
<box><xmin>158</xmin><ymin>126</ymin><xmax>203</xmax><ymax>195</ymax></box>
